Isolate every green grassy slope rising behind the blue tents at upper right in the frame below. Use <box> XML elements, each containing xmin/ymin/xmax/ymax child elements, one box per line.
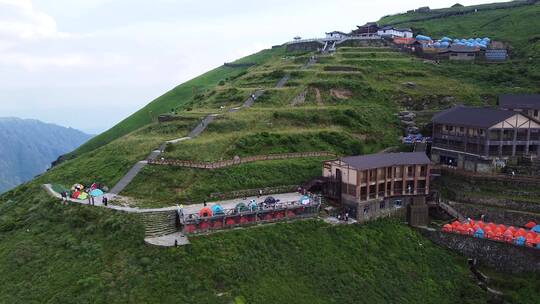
<box><xmin>379</xmin><ymin>3</ymin><xmax>540</xmax><ymax>57</ymax></box>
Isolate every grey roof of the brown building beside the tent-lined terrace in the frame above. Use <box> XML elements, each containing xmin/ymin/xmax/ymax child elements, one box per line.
<box><xmin>340</xmin><ymin>152</ymin><xmax>431</xmax><ymax>170</ymax></box>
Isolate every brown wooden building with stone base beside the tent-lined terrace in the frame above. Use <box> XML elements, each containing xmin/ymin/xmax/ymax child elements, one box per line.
<box><xmin>323</xmin><ymin>152</ymin><xmax>431</xmax><ymax>223</ymax></box>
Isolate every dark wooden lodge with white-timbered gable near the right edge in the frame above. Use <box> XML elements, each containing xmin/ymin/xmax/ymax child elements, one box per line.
<box><xmin>431</xmin><ymin>106</ymin><xmax>540</xmax><ymax>172</ymax></box>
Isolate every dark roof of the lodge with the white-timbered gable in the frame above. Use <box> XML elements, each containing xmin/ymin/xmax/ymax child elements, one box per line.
<box><xmin>433</xmin><ymin>106</ymin><xmax>516</xmax><ymax>128</ymax></box>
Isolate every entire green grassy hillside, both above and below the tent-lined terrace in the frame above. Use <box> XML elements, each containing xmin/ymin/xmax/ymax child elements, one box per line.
<box><xmin>0</xmin><ymin>1</ymin><xmax>540</xmax><ymax>303</ymax></box>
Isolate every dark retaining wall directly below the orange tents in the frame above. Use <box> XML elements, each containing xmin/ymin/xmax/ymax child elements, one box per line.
<box><xmin>418</xmin><ymin>229</ymin><xmax>540</xmax><ymax>273</ymax></box>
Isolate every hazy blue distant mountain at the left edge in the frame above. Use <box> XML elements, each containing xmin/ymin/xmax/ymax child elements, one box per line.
<box><xmin>0</xmin><ymin>117</ymin><xmax>92</xmax><ymax>193</ymax></box>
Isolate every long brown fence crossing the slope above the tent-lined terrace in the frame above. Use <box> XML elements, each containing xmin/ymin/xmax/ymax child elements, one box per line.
<box><xmin>148</xmin><ymin>152</ymin><xmax>336</xmax><ymax>169</ymax></box>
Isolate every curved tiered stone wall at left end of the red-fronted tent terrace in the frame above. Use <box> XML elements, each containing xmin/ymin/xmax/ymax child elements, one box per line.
<box><xmin>140</xmin><ymin>210</ymin><xmax>179</xmax><ymax>238</ymax></box>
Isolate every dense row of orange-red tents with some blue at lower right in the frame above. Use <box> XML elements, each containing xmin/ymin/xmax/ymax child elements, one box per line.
<box><xmin>442</xmin><ymin>220</ymin><xmax>540</xmax><ymax>249</ymax></box>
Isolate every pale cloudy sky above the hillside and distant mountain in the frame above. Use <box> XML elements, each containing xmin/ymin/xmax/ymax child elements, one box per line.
<box><xmin>0</xmin><ymin>0</ymin><xmax>508</xmax><ymax>133</ymax></box>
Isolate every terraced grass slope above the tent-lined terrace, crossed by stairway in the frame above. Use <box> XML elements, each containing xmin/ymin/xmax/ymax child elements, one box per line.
<box><xmin>41</xmin><ymin>41</ymin><xmax>538</xmax><ymax>207</ymax></box>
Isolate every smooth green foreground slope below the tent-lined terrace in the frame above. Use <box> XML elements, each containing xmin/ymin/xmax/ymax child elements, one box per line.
<box><xmin>0</xmin><ymin>186</ymin><xmax>485</xmax><ymax>303</ymax></box>
